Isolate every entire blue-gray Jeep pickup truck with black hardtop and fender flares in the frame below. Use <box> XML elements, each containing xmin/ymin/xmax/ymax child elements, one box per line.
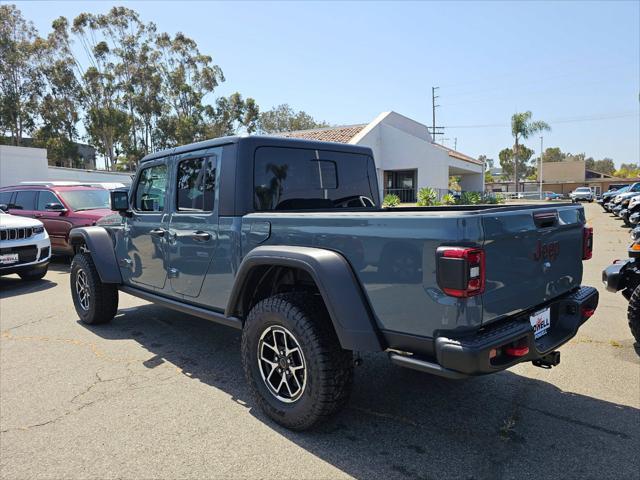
<box><xmin>71</xmin><ymin>136</ymin><xmax>598</xmax><ymax>430</ymax></box>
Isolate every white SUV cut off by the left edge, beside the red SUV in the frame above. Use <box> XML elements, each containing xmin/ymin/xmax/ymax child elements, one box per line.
<box><xmin>0</xmin><ymin>209</ymin><xmax>51</xmax><ymax>280</ymax></box>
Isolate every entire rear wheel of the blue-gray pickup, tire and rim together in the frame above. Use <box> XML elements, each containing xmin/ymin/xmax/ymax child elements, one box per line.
<box><xmin>242</xmin><ymin>293</ymin><xmax>353</xmax><ymax>430</ymax></box>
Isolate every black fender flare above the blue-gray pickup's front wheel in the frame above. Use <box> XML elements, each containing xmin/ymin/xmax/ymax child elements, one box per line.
<box><xmin>69</xmin><ymin>227</ymin><xmax>122</xmax><ymax>284</ymax></box>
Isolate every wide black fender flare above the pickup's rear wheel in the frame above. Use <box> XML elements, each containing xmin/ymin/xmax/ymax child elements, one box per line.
<box><xmin>225</xmin><ymin>245</ymin><xmax>384</xmax><ymax>352</ymax></box>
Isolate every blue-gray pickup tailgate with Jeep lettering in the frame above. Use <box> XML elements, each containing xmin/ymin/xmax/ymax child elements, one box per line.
<box><xmin>482</xmin><ymin>205</ymin><xmax>585</xmax><ymax>323</ymax></box>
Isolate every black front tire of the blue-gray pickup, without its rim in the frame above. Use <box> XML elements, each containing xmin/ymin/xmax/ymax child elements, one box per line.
<box><xmin>70</xmin><ymin>252</ymin><xmax>118</xmax><ymax>325</ymax></box>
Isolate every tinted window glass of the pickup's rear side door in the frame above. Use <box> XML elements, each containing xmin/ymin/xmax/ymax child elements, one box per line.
<box><xmin>176</xmin><ymin>156</ymin><xmax>216</xmax><ymax>212</ymax></box>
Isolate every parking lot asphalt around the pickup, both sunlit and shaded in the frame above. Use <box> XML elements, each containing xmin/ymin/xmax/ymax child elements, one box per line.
<box><xmin>0</xmin><ymin>204</ymin><xmax>640</xmax><ymax>479</ymax></box>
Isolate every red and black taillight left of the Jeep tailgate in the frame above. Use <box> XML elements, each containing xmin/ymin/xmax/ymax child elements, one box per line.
<box><xmin>436</xmin><ymin>247</ymin><xmax>485</xmax><ymax>298</ymax></box>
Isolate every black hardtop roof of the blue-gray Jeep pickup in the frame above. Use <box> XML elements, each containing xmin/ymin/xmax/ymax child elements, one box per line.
<box><xmin>140</xmin><ymin>135</ymin><xmax>371</xmax><ymax>162</ymax></box>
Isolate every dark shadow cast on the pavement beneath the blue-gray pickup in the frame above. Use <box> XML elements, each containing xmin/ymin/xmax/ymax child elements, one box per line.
<box><xmin>83</xmin><ymin>305</ymin><xmax>640</xmax><ymax>479</ymax></box>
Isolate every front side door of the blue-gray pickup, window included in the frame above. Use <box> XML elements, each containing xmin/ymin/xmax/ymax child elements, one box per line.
<box><xmin>123</xmin><ymin>159</ymin><xmax>169</xmax><ymax>289</ymax></box>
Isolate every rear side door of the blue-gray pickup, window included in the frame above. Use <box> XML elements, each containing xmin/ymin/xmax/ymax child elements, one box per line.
<box><xmin>167</xmin><ymin>147</ymin><xmax>222</xmax><ymax>298</ymax></box>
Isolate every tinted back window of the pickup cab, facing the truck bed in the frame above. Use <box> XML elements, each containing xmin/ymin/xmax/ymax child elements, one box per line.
<box><xmin>254</xmin><ymin>147</ymin><xmax>376</xmax><ymax>211</ymax></box>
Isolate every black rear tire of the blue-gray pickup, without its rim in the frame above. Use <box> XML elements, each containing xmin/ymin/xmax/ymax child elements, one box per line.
<box><xmin>242</xmin><ymin>293</ymin><xmax>353</xmax><ymax>430</ymax></box>
